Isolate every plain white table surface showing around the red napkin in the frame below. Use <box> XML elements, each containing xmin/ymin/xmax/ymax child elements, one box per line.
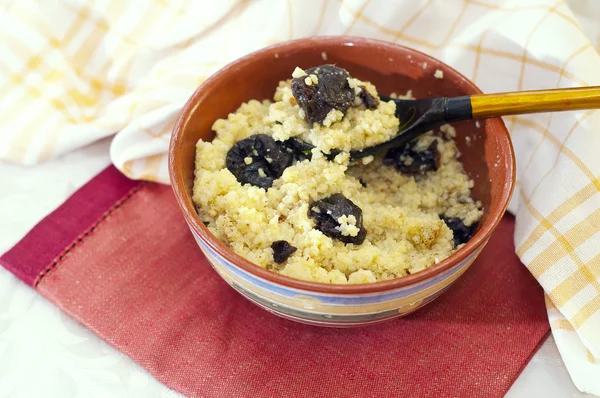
<box><xmin>0</xmin><ymin>140</ymin><xmax>591</xmax><ymax>398</ymax></box>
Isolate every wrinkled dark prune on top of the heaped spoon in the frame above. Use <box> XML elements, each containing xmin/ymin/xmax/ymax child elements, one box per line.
<box><xmin>292</xmin><ymin>65</ymin><xmax>356</xmax><ymax>124</ymax></box>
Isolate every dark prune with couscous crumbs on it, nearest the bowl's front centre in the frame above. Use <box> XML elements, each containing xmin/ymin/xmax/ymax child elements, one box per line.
<box><xmin>308</xmin><ymin>193</ymin><xmax>367</xmax><ymax>245</ymax></box>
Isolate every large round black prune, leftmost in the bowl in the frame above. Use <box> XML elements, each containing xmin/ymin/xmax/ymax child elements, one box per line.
<box><xmin>225</xmin><ymin>134</ymin><xmax>294</xmax><ymax>189</ymax></box>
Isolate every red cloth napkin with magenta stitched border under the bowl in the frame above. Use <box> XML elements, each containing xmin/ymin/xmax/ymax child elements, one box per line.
<box><xmin>0</xmin><ymin>167</ymin><xmax>549</xmax><ymax>397</ymax></box>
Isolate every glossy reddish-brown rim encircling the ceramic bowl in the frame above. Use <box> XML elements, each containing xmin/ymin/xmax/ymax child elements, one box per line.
<box><xmin>168</xmin><ymin>36</ymin><xmax>516</xmax><ymax>295</ymax></box>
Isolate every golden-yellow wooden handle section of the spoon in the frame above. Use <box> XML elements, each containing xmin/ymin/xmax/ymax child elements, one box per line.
<box><xmin>471</xmin><ymin>86</ymin><xmax>600</xmax><ymax>118</ymax></box>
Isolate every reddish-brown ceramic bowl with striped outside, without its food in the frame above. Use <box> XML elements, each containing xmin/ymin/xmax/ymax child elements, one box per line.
<box><xmin>169</xmin><ymin>36</ymin><xmax>515</xmax><ymax>326</ymax></box>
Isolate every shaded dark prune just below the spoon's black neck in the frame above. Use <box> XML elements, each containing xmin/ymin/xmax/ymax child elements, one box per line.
<box><xmin>383</xmin><ymin>140</ymin><xmax>439</xmax><ymax>175</ymax></box>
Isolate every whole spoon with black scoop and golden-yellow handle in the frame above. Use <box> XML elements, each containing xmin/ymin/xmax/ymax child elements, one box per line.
<box><xmin>330</xmin><ymin>86</ymin><xmax>600</xmax><ymax>159</ymax></box>
